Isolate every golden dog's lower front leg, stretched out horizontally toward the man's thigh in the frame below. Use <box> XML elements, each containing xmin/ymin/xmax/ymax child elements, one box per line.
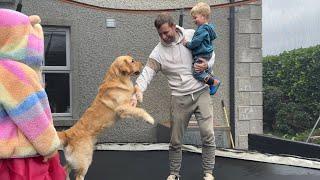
<box><xmin>115</xmin><ymin>105</ymin><xmax>154</xmax><ymax>124</ymax></box>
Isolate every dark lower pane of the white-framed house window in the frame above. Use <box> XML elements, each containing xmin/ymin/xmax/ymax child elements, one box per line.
<box><xmin>45</xmin><ymin>73</ymin><xmax>70</xmax><ymax>113</ymax></box>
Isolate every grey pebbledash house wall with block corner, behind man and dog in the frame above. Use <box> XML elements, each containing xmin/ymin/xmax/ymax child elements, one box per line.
<box><xmin>0</xmin><ymin>0</ymin><xmax>263</xmax><ymax>149</ymax></box>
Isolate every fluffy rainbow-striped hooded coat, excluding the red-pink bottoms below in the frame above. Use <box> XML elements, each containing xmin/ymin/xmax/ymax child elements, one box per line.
<box><xmin>0</xmin><ymin>9</ymin><xmax>60</xmax><ymax>159</ymax></box>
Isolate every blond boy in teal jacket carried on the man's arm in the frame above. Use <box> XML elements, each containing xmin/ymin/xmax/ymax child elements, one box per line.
<box><xmin>183</xmin><ymin>2</ymin><xmax>220</xmax><ymax>95</ymax></box>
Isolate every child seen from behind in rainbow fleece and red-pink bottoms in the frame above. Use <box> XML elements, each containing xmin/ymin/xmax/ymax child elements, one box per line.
<box><xmin>0</xmin><ymin>9</ymin><xmax>66</xmax><ymax>180</ymax></box>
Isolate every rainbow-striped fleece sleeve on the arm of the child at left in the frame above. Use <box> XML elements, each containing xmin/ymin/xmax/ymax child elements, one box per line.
<box><xmin>0</xmin><ymin>67</ymin><xmax>60</xmax><ymax>156</ymax></box>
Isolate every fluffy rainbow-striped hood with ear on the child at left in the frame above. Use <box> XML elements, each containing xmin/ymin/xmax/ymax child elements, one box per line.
<box><xmin>0</xmin><ymin>9</ymin><xmax>44</xmax><ymax>71</ymax></box>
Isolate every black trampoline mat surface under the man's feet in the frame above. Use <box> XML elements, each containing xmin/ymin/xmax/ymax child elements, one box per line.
<box><xmin>60</xmin><ymin>151</ymin><xmax>320</xmax><ymax>180</ymax></box>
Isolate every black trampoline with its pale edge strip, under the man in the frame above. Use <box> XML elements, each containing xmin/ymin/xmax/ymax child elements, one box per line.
<box><xmin>62</xmin><ymin>144</ymin><xmax>320</xmax><ymax>180</ymax></box>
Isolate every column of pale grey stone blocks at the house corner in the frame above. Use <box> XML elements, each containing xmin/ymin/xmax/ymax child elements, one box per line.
<box><xmin>234</xmin><ymin>1</ymin><xmax>263</xmax><ymax>149</ymax></box>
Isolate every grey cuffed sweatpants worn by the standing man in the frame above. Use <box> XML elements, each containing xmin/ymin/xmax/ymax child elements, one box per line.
<box><xmin>169</xmin><ymin>88</ymin><xmax>216</xmax><ymax>175</ymax></box>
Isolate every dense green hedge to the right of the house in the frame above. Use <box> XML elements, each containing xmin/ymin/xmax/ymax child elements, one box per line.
<box><xmin>263</xmin><ymin>45</ymin><xmax>320</xmax><ymax>134</ymax></box>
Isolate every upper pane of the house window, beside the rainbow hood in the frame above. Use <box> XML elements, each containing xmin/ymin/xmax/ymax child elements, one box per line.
<box><xmin>44</xmin><ymin>29</ymin><xmax>67</xmax><ymax>66</ymax></box>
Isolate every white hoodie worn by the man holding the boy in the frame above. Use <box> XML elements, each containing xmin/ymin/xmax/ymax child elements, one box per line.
<box><xmin>136</xmin><ymin>26</ymin><xmax>215</xmax><ymax>96</ymax></box>
